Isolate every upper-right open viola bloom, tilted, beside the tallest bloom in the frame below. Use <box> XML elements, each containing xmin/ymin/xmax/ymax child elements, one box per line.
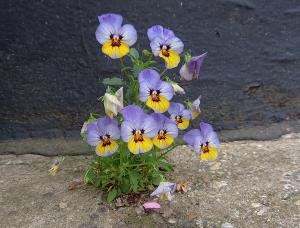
<box><xmin>147</xmin><ymin>25</ymin><xmax>184</xmax><ymax>69</ymax></box>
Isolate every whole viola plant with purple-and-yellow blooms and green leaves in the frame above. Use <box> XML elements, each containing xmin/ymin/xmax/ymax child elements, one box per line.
<box><xmin>82</xmin><ymin>14</ymin><xmax>219</xmax><ymax>199</ymax></box>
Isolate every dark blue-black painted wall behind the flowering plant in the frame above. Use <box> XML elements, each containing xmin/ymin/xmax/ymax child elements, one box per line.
<box><xmin>0</xmin><ymin>0</ymin><xmax>300</xmax><ymax>139</ymax></box>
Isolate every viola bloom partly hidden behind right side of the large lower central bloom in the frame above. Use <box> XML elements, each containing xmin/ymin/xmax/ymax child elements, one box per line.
<box><xmin>151</xmin><ymin>113</ymin><xmax>178</xmax><ymax>149</ymax></box>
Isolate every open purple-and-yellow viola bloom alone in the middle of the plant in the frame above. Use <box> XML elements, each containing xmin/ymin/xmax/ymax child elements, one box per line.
<box><xmin>139</xmin><ymin>69</ymin><xmax>174</xmax><ymax>113</ymax></box>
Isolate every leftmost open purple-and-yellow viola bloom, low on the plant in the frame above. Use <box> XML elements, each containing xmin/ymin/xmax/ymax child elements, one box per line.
<box><xmin>87</xmin><ymin>116</ymin><xmax>120</xmax><ymax>157</ymax></box>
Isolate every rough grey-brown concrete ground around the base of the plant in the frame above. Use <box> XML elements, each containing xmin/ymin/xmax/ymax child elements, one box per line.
<box><xmin>0</xmin><ymin>134</ymin><xmax>300</xmax><ymax>228</ymax></box>
